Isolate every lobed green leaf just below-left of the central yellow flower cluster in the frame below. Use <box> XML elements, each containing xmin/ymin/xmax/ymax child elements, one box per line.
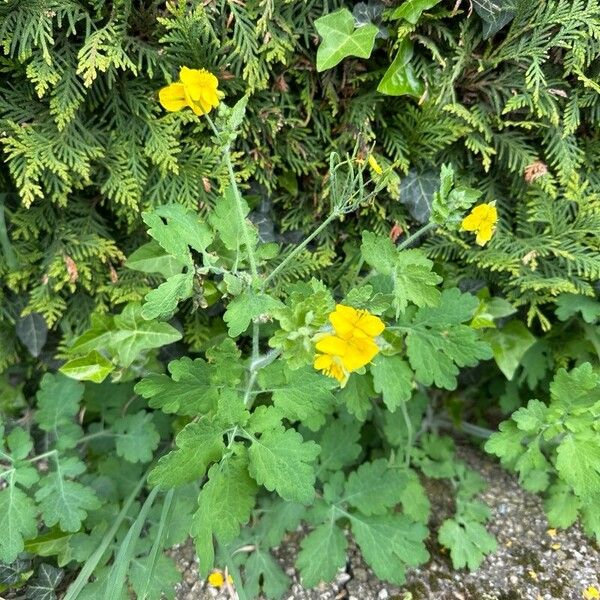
<box><xmin>260</xmin><ymin>362</ymin><xmax>336</xmax><ymax>431</ymax></box>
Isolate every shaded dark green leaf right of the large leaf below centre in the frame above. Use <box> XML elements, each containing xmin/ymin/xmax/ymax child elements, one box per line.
<box><xmin>319</xmin><ymin>419</ymin><xmax>362</xmax><ymax>474</ymax></box>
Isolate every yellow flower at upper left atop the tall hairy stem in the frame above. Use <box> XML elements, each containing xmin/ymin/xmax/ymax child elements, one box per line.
<box><xmin>158</xmin><ymin>67</ymin><xmax>221</xmax><ymax>115</ymax></box>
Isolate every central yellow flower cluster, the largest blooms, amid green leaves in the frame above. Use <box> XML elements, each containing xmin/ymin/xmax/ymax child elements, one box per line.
<box><xmin>314</xmin><ymin>304</ymin><xmax>385</xmax><ymax>386</ymax></box>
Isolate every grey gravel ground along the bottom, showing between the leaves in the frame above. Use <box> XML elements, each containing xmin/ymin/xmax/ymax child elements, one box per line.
<box><xmin>173</xmin><ymin>447</ymin><xmax>600</xmax><ymax>600</ymax></box>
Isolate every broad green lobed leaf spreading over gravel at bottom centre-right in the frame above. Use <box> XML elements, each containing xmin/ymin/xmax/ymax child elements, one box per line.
<box><xmin>350</xmin><ymin>513</ymin><xmax>429</xmax><ymax>585</ymax></box>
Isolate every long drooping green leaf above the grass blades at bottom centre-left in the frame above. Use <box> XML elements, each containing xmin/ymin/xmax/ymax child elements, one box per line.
<box><xmin>192</xmin><ymin>454</ymin><xmax>258</xmax><ymax>573</ymax></box>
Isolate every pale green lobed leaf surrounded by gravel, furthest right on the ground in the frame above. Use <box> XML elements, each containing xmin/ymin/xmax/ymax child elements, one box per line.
<box><xmin>438</xmin><ymin>519</ymin><xmax>497</xmax><ymax>571</ymax></box>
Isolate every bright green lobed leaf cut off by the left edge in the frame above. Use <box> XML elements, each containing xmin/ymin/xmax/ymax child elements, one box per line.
<box><xmin>0</xmin><ymin>480</ymin><xmax>37</xmax><ymax>564</ymax></box>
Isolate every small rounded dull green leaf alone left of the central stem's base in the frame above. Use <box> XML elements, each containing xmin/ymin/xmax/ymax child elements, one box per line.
<box><xmin>113</xmin><ymin>410</ymin><xmax>160</xmax><ymax>463</ymax></box>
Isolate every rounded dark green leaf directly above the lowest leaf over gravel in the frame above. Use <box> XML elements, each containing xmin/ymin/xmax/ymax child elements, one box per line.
<box><xmin>343</xmin><ymin>458</ymin><xmax>406</xmax><ymax>516</ymax></box>
